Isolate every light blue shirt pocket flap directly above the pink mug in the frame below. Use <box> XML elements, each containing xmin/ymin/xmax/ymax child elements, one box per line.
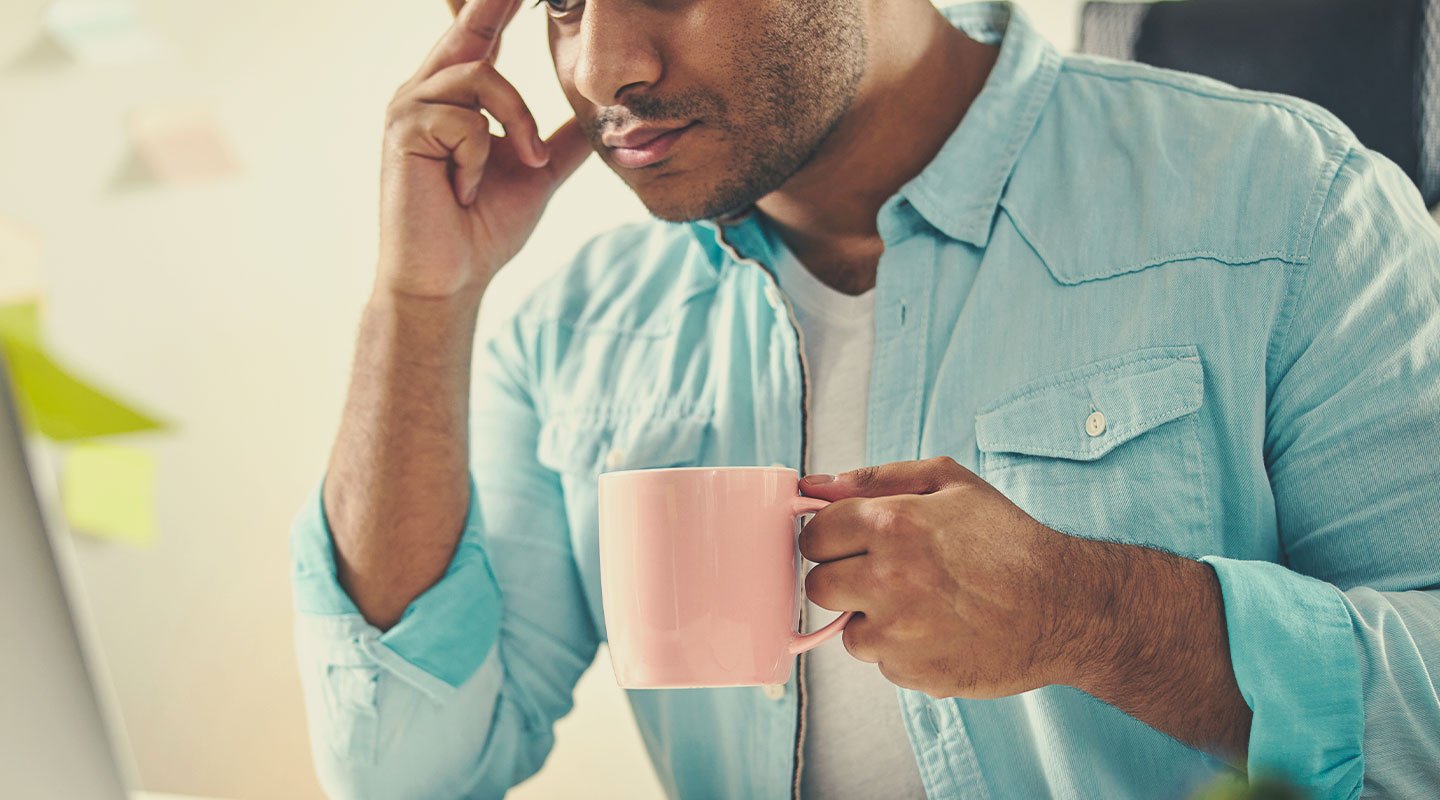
<box><xmin>536</xmin><ymin>414</ymin><xmax>710</xmax><ymax>473</ymax></box>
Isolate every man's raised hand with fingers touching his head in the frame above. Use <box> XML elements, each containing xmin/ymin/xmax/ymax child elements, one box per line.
<box><xmin>376</xmin><ymin>0</ymin><xmax>592</xmax><ymax>299</ymax></box>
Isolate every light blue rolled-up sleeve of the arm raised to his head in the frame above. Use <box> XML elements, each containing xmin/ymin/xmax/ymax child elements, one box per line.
<box><xmin>289</xmin><ymin>309</ymin><xmax>598</xmax><ymax>797</ymax></box>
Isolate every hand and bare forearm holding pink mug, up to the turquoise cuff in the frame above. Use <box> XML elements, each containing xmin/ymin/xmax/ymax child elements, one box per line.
<box><xmin>799</xmin><ymin>456</ymin><xmax>1250</xmax><ymax>764</ymax></box>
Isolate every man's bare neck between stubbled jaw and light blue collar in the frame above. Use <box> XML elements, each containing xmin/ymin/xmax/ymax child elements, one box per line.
<box><xmin>756</xmin><ymin>3</ymin><xmax>999</xmax><ymax>295</ymax></box>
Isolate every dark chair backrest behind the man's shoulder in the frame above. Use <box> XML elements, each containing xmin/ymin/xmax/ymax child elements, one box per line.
<box><xmin>1080</xmin><ymin>0</ymin><xmax>1440</xmax><ymax>207</ymax></box>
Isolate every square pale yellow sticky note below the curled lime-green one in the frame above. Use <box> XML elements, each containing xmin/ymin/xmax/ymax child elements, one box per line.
<box><xmin>60</xmin><ymin>442</ymin><xmax>156</xmax><ymax>547</ymax></box>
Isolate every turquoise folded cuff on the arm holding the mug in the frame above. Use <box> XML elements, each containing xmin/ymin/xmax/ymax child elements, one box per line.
<box><xmin>1201</xmin><ymin>555</ymin><xmax>1365</xmax><ymax>797</ymax></box>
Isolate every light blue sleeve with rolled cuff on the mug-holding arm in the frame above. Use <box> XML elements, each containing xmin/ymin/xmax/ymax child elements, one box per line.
<box><xmin>1204</xmin><ymin>147</ymin><xmax>1440</xmax><ymax>797</ymax></box>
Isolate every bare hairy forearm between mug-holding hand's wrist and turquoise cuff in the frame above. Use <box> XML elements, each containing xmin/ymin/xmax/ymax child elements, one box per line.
<box><xmin>1066</xmin><ymin>537</ymin><xmax>1251</xmax><ymax>768</ymax></box>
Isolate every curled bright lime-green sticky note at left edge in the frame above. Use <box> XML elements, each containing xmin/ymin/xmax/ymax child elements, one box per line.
<box><xmin>0</xmin><ymin>301</ymin><xmax>166</xmax><ymax>442</ymax></box>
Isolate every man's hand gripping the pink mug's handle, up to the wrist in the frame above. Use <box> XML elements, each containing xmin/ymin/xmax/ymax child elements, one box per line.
<box><xmin>801</xmin><ymin>456</ymin><xmax>1080</xmax><ymax>698</ymax></box>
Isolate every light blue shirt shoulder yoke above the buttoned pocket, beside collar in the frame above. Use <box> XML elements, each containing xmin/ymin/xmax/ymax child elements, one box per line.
<box><xmin>1001</xmin><ymin>56</ymin><xmax>1359</xmax><ymax>283</ymax></box>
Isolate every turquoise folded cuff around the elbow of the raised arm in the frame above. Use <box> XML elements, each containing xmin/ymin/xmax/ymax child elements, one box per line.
<box><xmin>289</xmin><ymin>475</ymin><xmax>501</xmax><ymax>695</ymax></box>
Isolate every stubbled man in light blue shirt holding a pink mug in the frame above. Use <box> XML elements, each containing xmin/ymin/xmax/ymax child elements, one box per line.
<box><xmin>291</xmin><ymin>0</ymin><xmax>1440</xmax><ymax>799</ymax></box>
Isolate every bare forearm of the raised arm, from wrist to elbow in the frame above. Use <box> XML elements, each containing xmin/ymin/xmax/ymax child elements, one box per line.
<box><xmin>324</xmin><ymin>280</ymin><xmax>480</xmax><ymax>630</ymax></box>
